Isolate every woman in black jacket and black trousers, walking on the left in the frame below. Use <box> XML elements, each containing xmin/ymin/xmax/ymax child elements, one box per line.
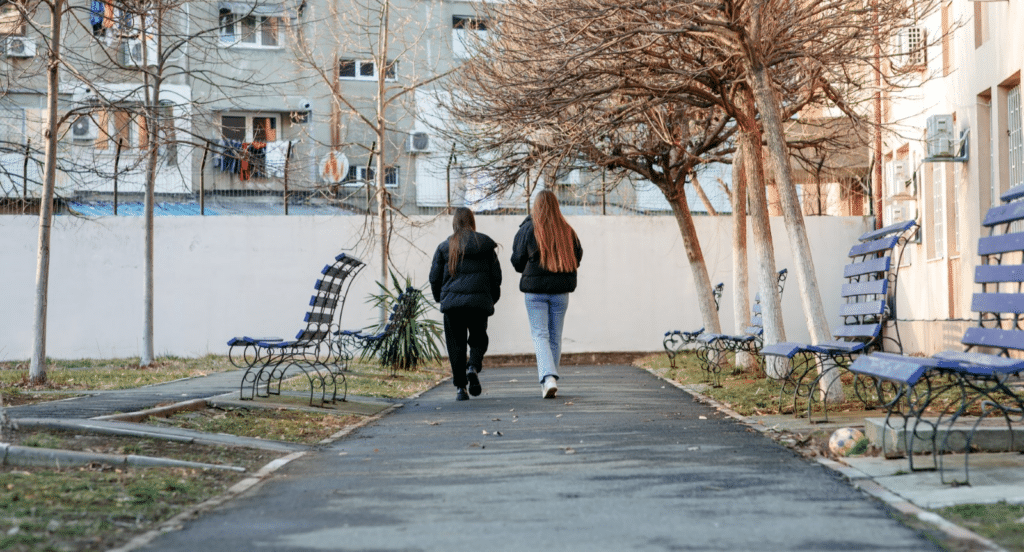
<box><xmin>430</xmin><ymin>207</ymin><xmax>502</xmax><ymax>400</ymax></box>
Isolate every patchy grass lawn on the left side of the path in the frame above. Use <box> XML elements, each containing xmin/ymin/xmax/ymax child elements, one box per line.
<box><xmin>0</xmin><ymin>355</ymin><xmax>446</xmax><ymax>552</ymax></box>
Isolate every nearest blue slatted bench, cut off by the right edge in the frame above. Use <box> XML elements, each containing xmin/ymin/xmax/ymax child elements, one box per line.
<box><xmin>850</xmin><ymin>185</ymin><xmax>1024</xmax><ymax>483</ymax></box>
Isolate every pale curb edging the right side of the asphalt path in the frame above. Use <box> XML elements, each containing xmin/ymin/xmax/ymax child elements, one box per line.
<box><xmin>638</xmin><ymin>367</ymin><xmax>1007</xmax><ymax>552</ymax></box>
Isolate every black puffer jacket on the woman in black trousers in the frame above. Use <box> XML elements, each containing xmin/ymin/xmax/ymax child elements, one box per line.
<box><xmin>430</xmin><ymin>232</ymin><xmax>502</xmax><ymax>316</ymax></box>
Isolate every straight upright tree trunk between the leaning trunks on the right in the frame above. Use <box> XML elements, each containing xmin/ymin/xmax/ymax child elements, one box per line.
<box><xmin>731</xmin><ymin>147</ymin><xmax>757</xmax><ymax>372</ymax></box>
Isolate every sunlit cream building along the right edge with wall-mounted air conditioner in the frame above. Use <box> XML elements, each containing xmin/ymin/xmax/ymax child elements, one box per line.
<box><xmin>883</xmin><ymin>0</ymin><xmax>1024</xmax><ymax>353</ymax></box>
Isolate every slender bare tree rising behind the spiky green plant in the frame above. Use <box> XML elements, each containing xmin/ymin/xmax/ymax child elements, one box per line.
<box><xmin>291</xmin><ymin>0</ymin><xmax>451</xmax><ymax>292</ymax></box>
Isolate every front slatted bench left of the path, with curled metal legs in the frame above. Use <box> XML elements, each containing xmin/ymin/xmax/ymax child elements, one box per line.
<box><xmin>227</xmin><ymin>253</ymin><xmax>366</xmax><ymax>405</ymax></box>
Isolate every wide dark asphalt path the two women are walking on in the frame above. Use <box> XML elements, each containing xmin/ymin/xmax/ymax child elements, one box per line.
<box><xmin>142</xmin><ymin>366</ymin><xmax>938</xmax><ymax>552</ymax></box>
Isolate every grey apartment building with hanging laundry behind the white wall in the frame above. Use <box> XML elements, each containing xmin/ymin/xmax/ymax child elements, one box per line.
<box><xmin>0</xmin><ymin>0</ymin><xmax>512</xmax><ymax>212</ymax></box>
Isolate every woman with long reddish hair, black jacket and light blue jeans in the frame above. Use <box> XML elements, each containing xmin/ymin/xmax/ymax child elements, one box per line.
<box><xmin>512</xmin><ymin>189</ymin><xmax>583</xmax><ymax>398</ymax></box>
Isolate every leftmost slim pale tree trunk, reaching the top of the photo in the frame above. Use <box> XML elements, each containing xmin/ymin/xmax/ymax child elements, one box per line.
<box><xmin>29</xmin><ymin>0</ymin><xmax>65</xmax><ymax>384</ymax></box>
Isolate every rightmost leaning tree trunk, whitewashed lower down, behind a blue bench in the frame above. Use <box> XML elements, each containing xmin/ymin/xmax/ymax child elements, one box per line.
<box><xmin>748</xmin><ymin>68</ymin><xmax>844</xmax><ymax>402</ymax></box>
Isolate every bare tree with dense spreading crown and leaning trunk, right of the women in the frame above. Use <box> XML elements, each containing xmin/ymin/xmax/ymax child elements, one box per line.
<box><xmin>447</xmin><ymin>1</ymin><xmax>735</xmax><ymax>344</ymax></box>
